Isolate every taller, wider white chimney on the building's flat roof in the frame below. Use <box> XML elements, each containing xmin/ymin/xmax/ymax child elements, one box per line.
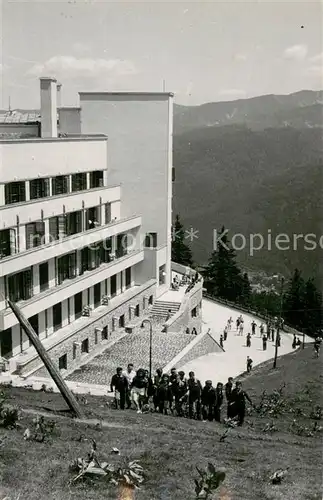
<box><xmin>40</xmin><ymin>77</ymin><xmax>57</xmax><ymax>137</ymax></box>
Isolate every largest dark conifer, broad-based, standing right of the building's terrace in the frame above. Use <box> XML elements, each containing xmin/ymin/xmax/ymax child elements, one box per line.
<box><xmin>204</xmin><ymin>227</ymin><xmax>250</xmax><ymax>303</ymax></box>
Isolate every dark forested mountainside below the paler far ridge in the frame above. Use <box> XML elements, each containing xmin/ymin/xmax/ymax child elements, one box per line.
<box><xmin>173</xmin><ymin>123</ymin><xmax>323</xmax><ymax>284</ymax></box>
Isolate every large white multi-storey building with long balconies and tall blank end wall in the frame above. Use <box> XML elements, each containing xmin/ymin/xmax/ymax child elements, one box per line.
<box><xmin>0</xmin><ymin>78</ymin><xmax>173</xmax><ymax>374</ymax></box>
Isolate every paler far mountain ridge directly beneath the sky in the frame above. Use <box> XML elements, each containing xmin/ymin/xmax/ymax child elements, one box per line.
<box><xmin>174</xmin><ymin>90</ymin><xmax>323</xmax><ymax>134</ymax></box>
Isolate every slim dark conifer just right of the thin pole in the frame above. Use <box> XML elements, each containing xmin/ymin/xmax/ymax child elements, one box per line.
<box><xmin>283</xmin><ymin>269</ymin><xmax>305</xmax><ymax>330</ymax></box>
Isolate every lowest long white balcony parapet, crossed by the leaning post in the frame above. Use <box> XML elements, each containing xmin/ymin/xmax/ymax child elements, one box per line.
<box><xmin>0</xmin><ymin>250</ymin><xmax>144</xmax><ymax>330</ymax></box>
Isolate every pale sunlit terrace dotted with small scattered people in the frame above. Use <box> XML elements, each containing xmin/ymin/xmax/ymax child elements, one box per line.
<box><xmin>177</xmin><ymin>299</ymin><xmax>309</xmax><ymax>384</ymax></box>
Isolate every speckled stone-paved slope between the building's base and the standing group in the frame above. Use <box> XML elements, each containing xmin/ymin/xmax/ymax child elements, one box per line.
<box><xmin>67</xmin><ymin>332</ymin><xmax>195</xmax><ymax>384</ymax></box>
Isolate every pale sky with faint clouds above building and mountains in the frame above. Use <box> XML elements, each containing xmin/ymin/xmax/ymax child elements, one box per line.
<box><xmin>0</xmin><ymin>0</ymin><xmax>323</xmax><ymax>109</ymax></box>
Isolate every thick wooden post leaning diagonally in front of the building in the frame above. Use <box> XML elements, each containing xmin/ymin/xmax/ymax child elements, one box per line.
<box><xmin>7</xmin><ymin>299</ymin><xmax>83</xmax><ymax>418</ymax></box>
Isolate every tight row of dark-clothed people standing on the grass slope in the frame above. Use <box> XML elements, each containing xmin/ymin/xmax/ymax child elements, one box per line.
<box><xmin>110</xmin><ymin>361</ymin><xmax>252</xmax><ymax>425</ymax></box>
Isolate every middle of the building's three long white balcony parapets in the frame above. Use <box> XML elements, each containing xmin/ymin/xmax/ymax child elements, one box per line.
<box><xmin>1</xmin><ymin>217</ymin><xmax>141</xmax><ymax>276</ymax></box>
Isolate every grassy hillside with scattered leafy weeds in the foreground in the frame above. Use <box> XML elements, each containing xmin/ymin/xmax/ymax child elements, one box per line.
<box><xmin>0</xmin><ymin>346</ymin><xmax>322</xmax><ymax>500</ymax></box>
